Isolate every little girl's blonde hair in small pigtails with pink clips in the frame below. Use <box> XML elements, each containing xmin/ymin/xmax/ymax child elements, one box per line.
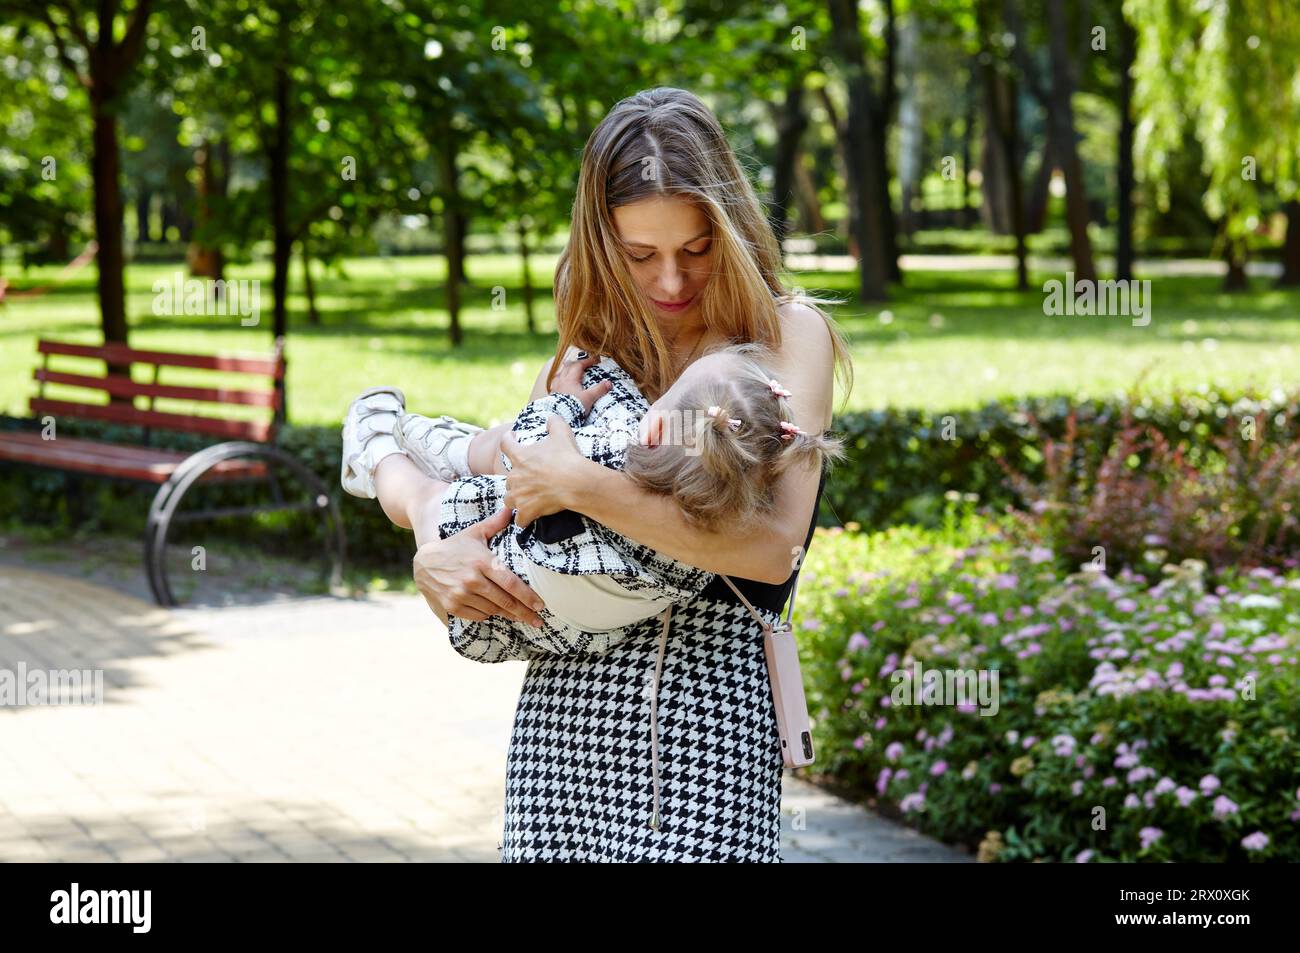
<box><xmin>623</xmin><ymin>342</ymin><xmax>844</xmax><ymax>533</ymax></box>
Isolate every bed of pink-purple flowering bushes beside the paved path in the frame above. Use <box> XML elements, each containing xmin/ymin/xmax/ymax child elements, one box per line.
<box><xmin>796</xmin><ymin>517</ymin><xmax>1300</xmax><ymax>862</ymax></box>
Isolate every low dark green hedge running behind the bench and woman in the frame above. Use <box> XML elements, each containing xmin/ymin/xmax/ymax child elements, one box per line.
<box><xmin>0</xmin><ymin>391</ymin><xmax>1300</xmax><ymax>566</ymax></box>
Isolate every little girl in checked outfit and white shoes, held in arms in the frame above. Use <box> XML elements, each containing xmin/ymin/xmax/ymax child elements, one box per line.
<box><xmin>342</xmin><ymin>343</ymin><xmax>842</xmax><ymax>662</ymax></box>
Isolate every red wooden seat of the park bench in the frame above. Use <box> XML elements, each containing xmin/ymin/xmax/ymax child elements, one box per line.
<box><xmin>0</xmin><ymin>430</ymin><xmax>267</xmax><ymax>484</ymax></box>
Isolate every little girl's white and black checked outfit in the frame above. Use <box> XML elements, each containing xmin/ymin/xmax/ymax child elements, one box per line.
<box><xmin>438</xmin><ymin>358</ymin><xmax>714</xmax><ymax>663</ymax></box>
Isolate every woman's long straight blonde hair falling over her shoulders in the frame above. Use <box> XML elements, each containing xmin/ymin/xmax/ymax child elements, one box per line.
<box><xmin>546</xmin><ymin>87</ymin><xmax>853</xmax><ymax>399</ymax></box>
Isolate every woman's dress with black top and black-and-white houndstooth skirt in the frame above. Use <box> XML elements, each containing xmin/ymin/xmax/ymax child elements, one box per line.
<box><xmin>501</xmin><ymin>468</ymin><xmax>826</xmax><ymax>863</ymax></box>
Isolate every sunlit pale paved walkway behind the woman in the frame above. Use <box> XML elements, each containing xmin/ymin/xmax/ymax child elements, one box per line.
<box><xmin>0</xmin><ymin>564</ymin><xmax>970</xmax><ymax>862</ymax></box>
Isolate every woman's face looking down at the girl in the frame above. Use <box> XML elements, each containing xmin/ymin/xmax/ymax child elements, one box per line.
<box><xmin>612</xmin><ymin>195</ymin><xmax>712</xmax><ymax>326</ymax></box>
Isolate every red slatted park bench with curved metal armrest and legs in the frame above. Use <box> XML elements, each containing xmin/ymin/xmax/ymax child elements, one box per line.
<box><xmin>0</xmin><ymin>338</ymin><xmax>343</xmax><ymax>606</ymax></box>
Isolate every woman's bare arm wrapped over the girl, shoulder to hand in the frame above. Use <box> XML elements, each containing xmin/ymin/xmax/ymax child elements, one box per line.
<box><xmin>503</xmin><ymin>306</ymin><xmax>835</xmax><ymax>584</ymax></box>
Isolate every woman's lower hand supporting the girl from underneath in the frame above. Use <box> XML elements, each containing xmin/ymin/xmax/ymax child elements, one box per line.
<box><xmin>412</xmin><ymin>506</ymin><xmax>545</xmax><ymax>628</ymax></box>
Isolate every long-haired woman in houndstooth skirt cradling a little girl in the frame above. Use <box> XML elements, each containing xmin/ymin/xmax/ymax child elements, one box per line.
<box><xmin>385</xmin><ymin>88</ymin><xmax>852</xmax><ymax>862</ymax></box>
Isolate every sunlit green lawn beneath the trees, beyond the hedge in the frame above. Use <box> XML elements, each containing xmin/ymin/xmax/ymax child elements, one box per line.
<box><xmin>0</xmin><ymin>255</ymin><xmax>1300</xmax><ymax>425</ymax></box>
